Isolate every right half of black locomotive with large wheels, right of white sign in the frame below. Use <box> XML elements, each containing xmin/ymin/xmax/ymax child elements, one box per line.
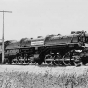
<box><xmin>40</xmin><ymin>31</ymin><xmax>88</xmax><ymax>65</ymax></box>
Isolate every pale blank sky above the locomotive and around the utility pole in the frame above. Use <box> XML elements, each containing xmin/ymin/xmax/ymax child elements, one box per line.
<box><xmin>0</xmin><ymin>0</ymin><xmax>88</xmax><ymax>40</ymax></box>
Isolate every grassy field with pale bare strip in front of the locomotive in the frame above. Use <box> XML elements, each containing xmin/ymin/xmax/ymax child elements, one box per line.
<box><xmin>0</xmin><ymin>65</ymin><xmax>88</xmax><ymax>88</ymax></box>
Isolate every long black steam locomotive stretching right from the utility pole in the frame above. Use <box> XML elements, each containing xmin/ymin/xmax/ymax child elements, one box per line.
<box><xmin>0</xmin><ymin>31</ymin><xmax>88</xmax><ymax>66</ymax></box>
